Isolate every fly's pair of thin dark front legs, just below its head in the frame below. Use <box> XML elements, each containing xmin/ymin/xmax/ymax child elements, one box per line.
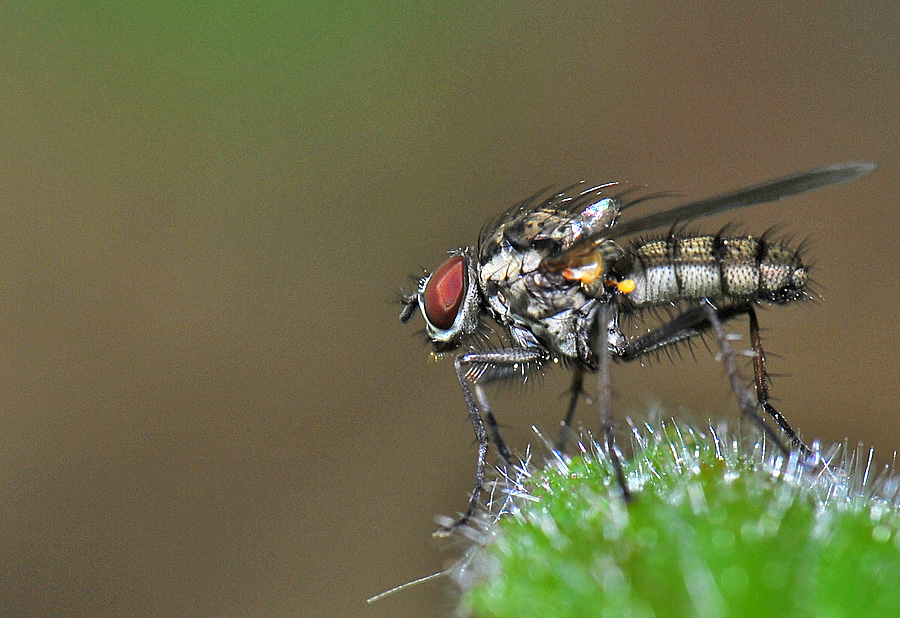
<box><xmin>435</xmin><ymin>346</ymin><xmax>549</xmax><ymax>536</ymax></box>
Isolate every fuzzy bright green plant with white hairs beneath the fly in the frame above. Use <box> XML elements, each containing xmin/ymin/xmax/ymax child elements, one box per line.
<box><xmin>454</xmin><ymin>423</ymin><xmax>900</xmax><ymax>618</ymax></box>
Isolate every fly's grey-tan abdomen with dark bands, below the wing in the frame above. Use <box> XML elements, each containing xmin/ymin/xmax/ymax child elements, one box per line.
<box><xmin>627</xmin><ymin>235</ymin><xmax>807</xmax><ymax>307</ymax></box>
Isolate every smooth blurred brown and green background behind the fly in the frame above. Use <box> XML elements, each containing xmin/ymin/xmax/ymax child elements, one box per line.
<box><xmin>0</xmin><ymin>2</ymin><xmax>900</xmax><ymax>618</ymax></box>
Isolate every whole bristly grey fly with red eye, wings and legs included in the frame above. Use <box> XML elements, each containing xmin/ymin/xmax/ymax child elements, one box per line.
<box><xmin>401</xmin><ymin>163</ymin><xmax>874</xmax><ymax>532</ymax></box>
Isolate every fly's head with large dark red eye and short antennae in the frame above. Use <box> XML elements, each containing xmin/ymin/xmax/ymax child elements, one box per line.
<box><xmin>400</xmin><ymin>251</ymin><xmax>481</xmax><ymax>352</ymax></box>
